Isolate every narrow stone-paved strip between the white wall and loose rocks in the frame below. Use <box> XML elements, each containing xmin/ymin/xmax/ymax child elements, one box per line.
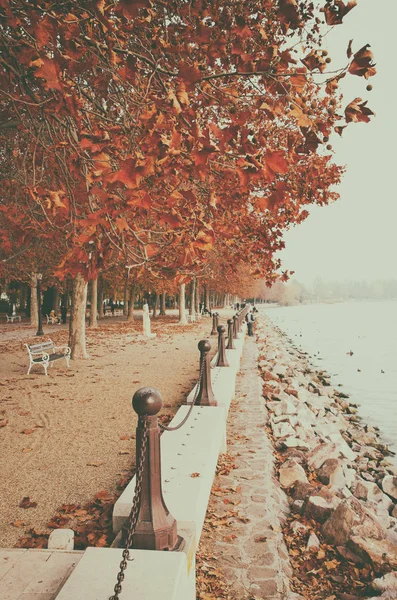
<box><xmin>201</xmin><ymin>338</ymin><xmax>299</xmax><ymax>600</ymax></box>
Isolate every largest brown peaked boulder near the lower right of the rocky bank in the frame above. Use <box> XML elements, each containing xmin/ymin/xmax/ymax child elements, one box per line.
<box><xmin>322</xmin><ymin>498</ymin><xmax>386</xmax><ymax>546</ymax></box>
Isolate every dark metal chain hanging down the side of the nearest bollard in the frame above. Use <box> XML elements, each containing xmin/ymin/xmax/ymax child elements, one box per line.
<box><xmin>109</xmin><ymin>417</ymin><xmax>147</xmax><ymax>600</ymax></box>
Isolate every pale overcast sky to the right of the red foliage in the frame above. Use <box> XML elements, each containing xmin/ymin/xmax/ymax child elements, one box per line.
<box><xmin>280</xmin><ymin>0</ymin><xmax>397</xmax><ymax>284</ymax></box>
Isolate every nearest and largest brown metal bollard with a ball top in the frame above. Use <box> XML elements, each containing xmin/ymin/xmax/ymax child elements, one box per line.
<box><xmin>131</xmin><ymin>387</ymin><xmax>183</xmax><ymax>550</ymax></box>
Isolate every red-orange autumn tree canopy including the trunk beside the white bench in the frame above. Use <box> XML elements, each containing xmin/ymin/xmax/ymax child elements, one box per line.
<box><xmin>0</xmin><ymin>0</ymin><xmax>375</xmax><ymax>357</ymax></box>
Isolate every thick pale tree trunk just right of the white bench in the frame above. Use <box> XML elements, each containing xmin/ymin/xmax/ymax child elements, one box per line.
<box><xmin>69</xmin><ymin>273</ymin><xmax>89</xmax><ymax>358</ymax></box>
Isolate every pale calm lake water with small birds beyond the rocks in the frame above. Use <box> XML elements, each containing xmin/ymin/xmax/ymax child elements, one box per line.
<box><xmin>262</xmin><ymin>300</ymin><xmax>397</xmax><ymax>463</ymax></box>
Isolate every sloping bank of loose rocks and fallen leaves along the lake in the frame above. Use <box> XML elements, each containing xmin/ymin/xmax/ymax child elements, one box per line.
<box><xmin>256</xmin><ymin>317</ymin><xmax>397</xmax><ymax>600</ymax></box>
